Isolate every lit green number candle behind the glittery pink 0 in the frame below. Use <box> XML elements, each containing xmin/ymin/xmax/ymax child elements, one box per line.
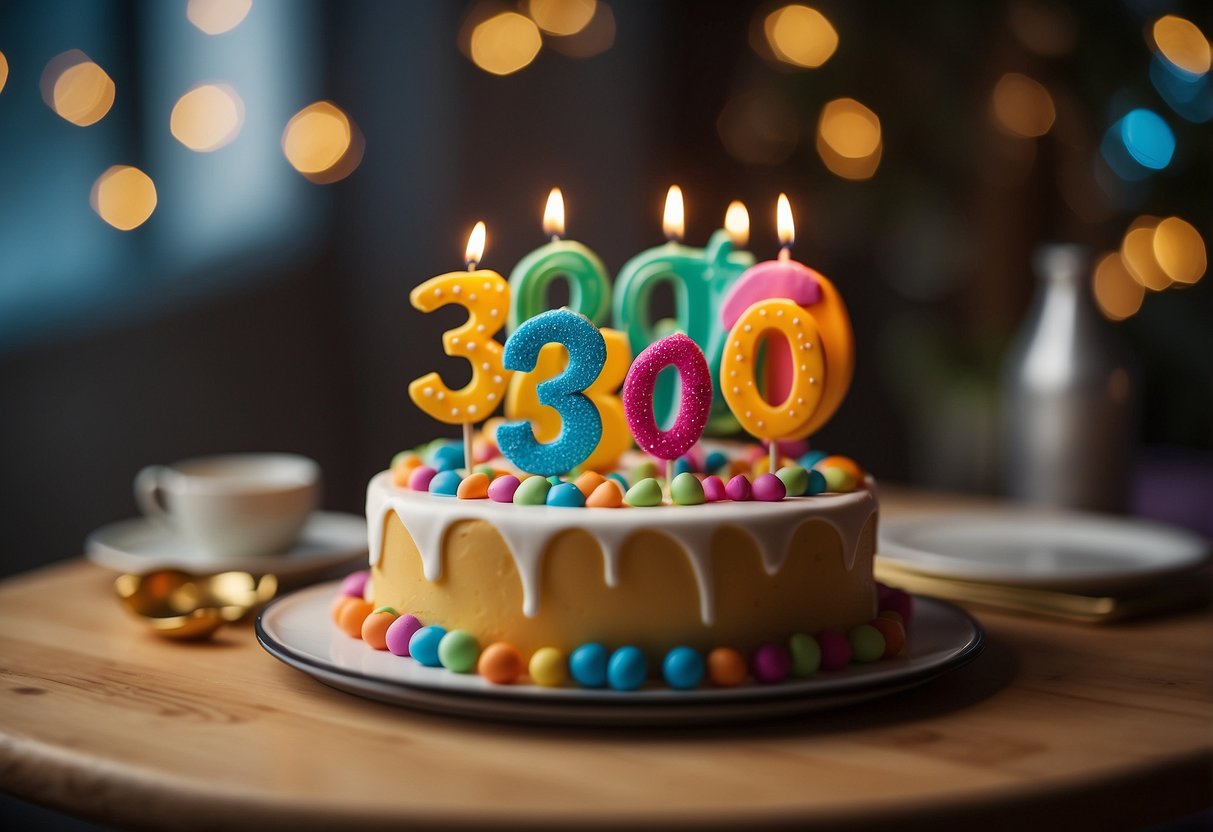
<box><xmin>614</xmin><ymin>186</ymin><xmax>754</xmax><ymax>424</ymax></box>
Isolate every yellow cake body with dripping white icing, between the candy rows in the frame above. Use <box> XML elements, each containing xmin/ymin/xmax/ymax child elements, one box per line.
<box><xmin>368</xmin><ymin>473</ymin><xmax>877</xmax><ymax>655</ymax></box>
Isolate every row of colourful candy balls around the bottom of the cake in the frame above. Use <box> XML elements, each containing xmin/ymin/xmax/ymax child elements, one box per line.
<box><xmin>332</xmin><ymin>571</ymin><xmax>913</xmax><ymax>691</ymax></box>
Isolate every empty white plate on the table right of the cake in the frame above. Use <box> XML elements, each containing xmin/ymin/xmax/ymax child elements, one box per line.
<box><xmin>877</xmin><ymin>508</ymin><xmax>1209</xmax><ymax>591</ymax></box>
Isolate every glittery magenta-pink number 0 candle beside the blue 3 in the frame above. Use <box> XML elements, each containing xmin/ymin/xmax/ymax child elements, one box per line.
<box><xmin>623</xmin><ymin>332</ymin><xmax>712</xmax><ymax>488</ymax></box>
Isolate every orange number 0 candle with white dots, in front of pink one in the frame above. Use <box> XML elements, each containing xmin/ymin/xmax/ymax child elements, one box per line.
<box><xmin>721</xmin><ymin>298</ymin><xmax>825</xmax><ymax>441</ymax></box>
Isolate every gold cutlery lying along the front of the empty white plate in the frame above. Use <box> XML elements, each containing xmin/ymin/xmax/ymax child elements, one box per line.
<box><xmin>876</xmin><ymin>558</ymin><xmax>1209</xmax><ymax>623</ymax></box>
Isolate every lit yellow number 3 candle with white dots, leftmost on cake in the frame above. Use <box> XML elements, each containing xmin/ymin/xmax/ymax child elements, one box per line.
<box><xmin>409</xmin><ymin>222</ymin><xmax>509</xmax><ymax>468</ymax></box>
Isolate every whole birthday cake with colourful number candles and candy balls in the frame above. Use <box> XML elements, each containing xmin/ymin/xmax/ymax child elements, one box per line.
<box><xmin>332</xmin><ymin>194</ymin><xmax>910</xmax><ymax>690</ymax></box>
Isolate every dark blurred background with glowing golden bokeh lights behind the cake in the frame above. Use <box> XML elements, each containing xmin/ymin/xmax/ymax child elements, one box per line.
<box><xmin>0</xmin><ymin>0</ymin><xmax>1213</xmax><ymax>572</ymax></box>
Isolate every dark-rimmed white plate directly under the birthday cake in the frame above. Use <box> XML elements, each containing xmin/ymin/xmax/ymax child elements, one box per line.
<box><xmin>257</xmin><ymin>583</ymin><xmax>985</xmax><ymax>725</ymax></box>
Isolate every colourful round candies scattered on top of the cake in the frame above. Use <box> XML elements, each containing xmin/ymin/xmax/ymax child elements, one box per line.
<box><xmin>391</xmin><ymin>445</ymin><xmax>864</xmax><ymax>508</ymax></box>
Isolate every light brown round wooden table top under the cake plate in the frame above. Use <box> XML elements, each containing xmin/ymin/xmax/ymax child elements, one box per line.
<box><xmin>0</xmin><ymin>495</ymin><xmax>1213</xmax><ymax>830</ymax></box>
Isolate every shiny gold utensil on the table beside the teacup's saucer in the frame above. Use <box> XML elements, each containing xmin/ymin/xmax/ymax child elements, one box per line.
<box><xmin>114</xmin><ymin>569</ymin><xmax>278</xmax><ymax>639</ymax></box>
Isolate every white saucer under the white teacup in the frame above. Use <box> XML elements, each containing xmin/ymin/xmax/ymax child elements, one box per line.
<box><xmin>85</xmin><ymin>512</ymin><xmax>366</xmax><ymax>579</ymax></box>
